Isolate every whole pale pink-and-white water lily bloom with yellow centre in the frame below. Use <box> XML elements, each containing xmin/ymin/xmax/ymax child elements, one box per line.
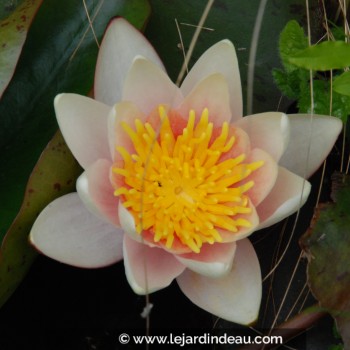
<box><xmin>30</xmin><ymin>18</ymin><xmax>342</xmax><ymax>324</ymax></box>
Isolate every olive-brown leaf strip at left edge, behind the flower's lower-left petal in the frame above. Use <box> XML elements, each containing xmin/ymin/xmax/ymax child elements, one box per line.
<box><xmin>0</xmin><ymin>132</ymin><xmax>81</xmax><ymax>306</ymax></box>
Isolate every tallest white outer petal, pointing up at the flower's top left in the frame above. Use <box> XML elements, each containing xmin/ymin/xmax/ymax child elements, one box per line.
<box><xmin>94</xmin><ymin>18</ymin><xmax>163</xmax><ymax>106</ymax></box>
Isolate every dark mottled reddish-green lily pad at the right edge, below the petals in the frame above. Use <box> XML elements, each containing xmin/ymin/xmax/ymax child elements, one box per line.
<box><xmin>301</xmin><ymin>174</ymin><xmax>350</xmax><ymax>349</ymax></box>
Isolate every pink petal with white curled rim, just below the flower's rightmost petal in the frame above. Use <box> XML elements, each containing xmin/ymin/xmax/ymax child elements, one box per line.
<box><xmin>257</xmin><ymin>167</ymin><xmax>311</xmax><ymax>229</ymax></box>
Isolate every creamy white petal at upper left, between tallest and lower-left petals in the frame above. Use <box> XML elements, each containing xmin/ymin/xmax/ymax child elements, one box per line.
<box><xmin>55</xmin><ymin>94</ymin><xmax>111</xmax><ymax>169</ymax></box>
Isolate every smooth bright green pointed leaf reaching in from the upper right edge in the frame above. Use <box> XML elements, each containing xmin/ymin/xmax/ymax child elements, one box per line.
<box><xmin>288</xmin><ymin>41</ymin><xmax>350</xmax><ymax>71</ymax></box>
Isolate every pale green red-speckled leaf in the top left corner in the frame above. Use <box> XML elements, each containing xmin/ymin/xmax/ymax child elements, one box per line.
<box><xmin>0</xmin><ymin>0</ymin><xmax>42</xmax><ymax>98</ymax></box>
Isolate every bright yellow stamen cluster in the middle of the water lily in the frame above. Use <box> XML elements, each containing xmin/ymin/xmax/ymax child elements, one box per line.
<box><xmin>112</xmin><ymin>106</ymin><xmax>263</xmax><ymax>253</ymax></box>
